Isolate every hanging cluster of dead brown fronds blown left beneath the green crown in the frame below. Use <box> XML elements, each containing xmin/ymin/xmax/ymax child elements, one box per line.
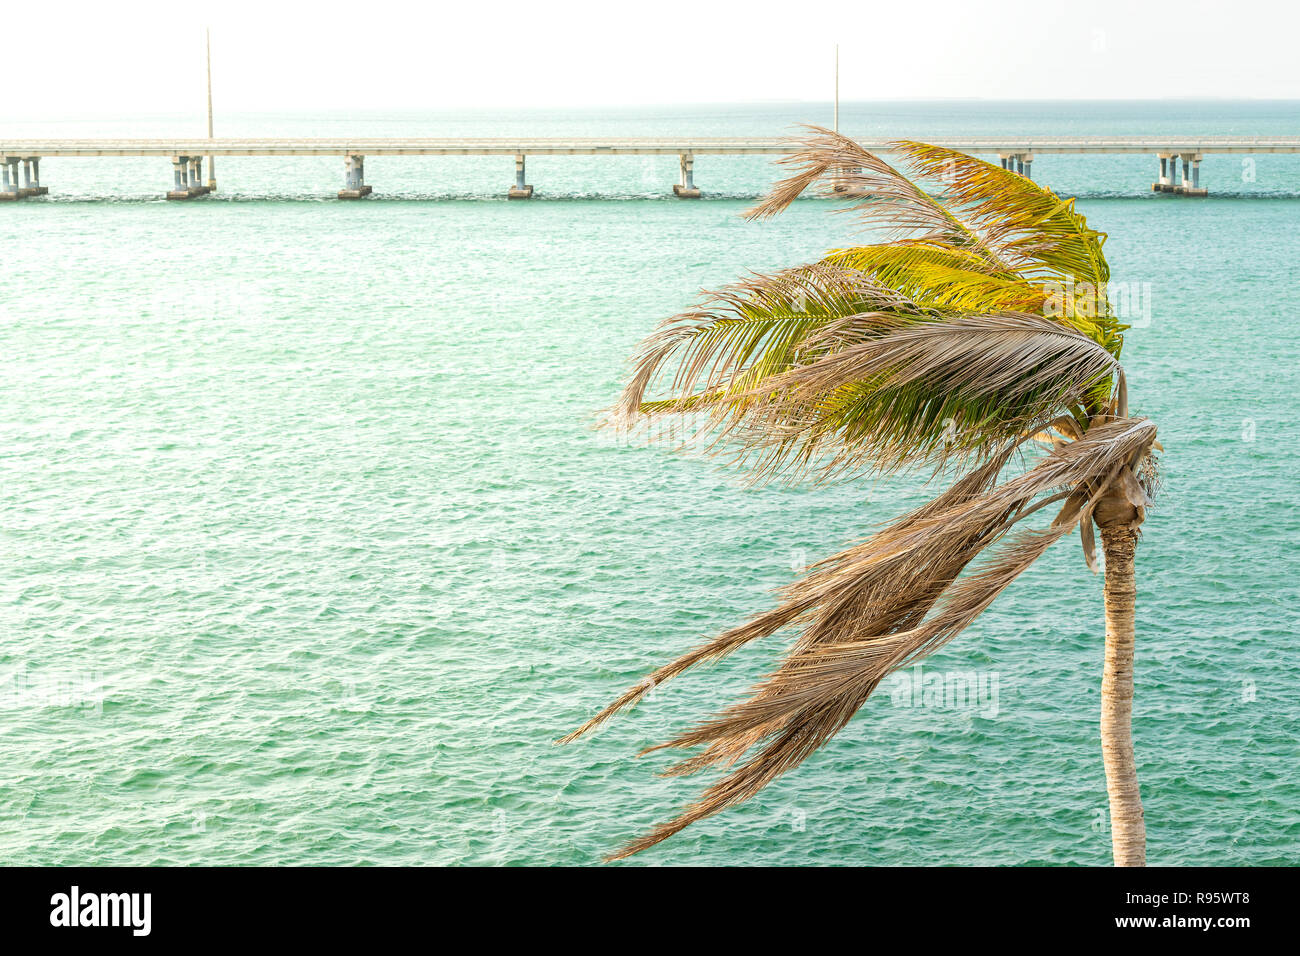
<box><xmin>567</xmin><ymin>419</ymin><xmax>1154</xmax><ymax>858</ymax></box>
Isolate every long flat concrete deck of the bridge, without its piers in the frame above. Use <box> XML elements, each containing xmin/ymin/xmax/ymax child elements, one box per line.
<box><xmin>0</xmin><ymin>137</ymin><xmax>1300</xmax><ymax>157</ymax></box>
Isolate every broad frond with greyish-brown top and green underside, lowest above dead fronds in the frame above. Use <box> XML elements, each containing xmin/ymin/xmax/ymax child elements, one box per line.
<box><xmin>714</xmin><ymin>315</ymin><xmax>1123</xmax><ymax>480</ymax></box>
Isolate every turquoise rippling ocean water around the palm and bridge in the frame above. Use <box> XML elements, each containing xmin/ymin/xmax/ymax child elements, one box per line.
<box><xmin>0</xmin><ymin>103</ymin><xmax>1300</xmax><ymax>865</ymax></box>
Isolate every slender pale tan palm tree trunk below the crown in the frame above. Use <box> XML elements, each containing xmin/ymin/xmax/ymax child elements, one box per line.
<box><xmin>1101</xmin><ymin>524</ymin><xmax>1147</xmax><ymax>866</ymax></box>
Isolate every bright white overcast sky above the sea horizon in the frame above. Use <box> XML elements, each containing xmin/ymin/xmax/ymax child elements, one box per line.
<box><xmin>0</xmin><ymin>0</ymin><xmax>1300</xmax><ymax>115</ymax></box>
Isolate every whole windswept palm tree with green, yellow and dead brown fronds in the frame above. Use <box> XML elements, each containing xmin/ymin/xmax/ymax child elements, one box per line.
<box><xmin>562</xmin><ymin>127</ymin><xmax>1160</xmax><ymax>866</ymax></box>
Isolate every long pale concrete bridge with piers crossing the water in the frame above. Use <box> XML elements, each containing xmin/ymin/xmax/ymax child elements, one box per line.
<box><xmin>0</xmin><ymin>137</ymin><xmax>1300</xmax><ymax>200</ymax></box>
